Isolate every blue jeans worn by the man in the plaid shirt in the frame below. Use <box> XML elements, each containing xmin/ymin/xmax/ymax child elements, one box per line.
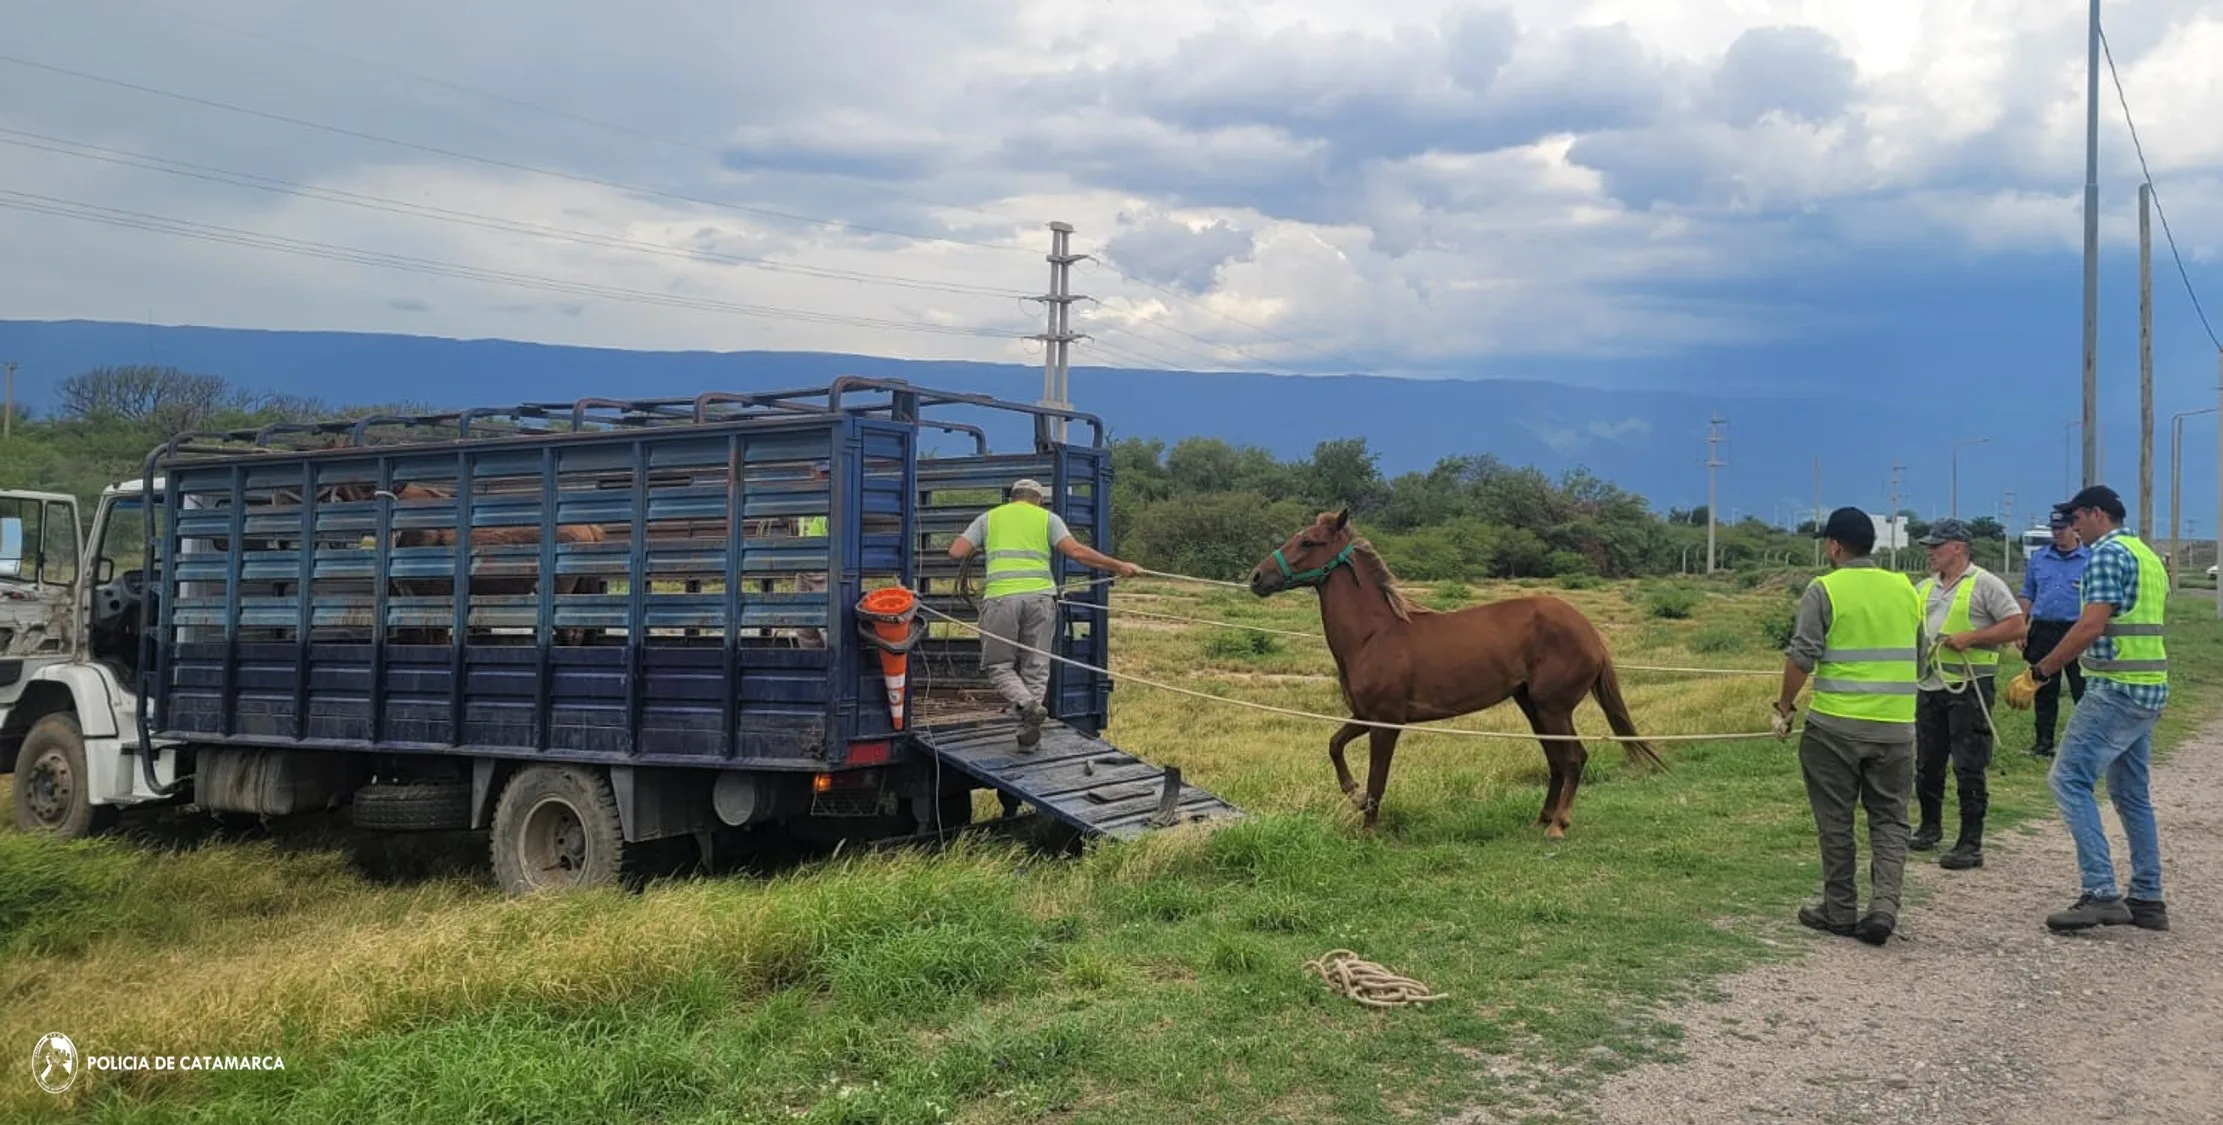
<box><xmin>2047</xmin><ymin>680</ymin><xmax>2161</xmax><ymax>900</ymax></box>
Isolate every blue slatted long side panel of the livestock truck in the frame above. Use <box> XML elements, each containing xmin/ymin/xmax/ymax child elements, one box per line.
<box><xmin>156</xmin><ymin>416</ymin><xmax>916</xmax><ymax>767</ymax></box>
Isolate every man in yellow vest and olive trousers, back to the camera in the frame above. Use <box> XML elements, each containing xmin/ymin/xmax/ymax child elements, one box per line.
<box><xmin>1776</xmin><ymin>507</ymin><xmax>1923</xmax><ymax>945</ymax></box>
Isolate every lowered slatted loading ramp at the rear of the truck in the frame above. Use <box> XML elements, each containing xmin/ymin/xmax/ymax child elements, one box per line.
<box><xmin>911</xmin><ymin>718</ymin><xmax>1243</xmax><ymax>840</ymax></box>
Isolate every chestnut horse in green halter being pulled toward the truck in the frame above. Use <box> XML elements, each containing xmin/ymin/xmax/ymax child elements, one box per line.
<box><xmin>1249</xmin><ymin>509</ymin><xmax>1667</xmax><ymax>840</ymax></box>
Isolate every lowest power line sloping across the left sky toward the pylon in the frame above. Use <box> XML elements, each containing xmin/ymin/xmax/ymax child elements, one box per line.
<box><xmin>0</xmin><ymin>189</ymin><xmax>1023</xmax><ymax>340</ymax></box>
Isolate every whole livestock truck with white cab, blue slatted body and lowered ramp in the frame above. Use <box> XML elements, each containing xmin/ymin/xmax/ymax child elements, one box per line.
<box><xmin>0</xmin><ymin>378</ymin><xmax>1236</xmax><ymax>892</ymax></box>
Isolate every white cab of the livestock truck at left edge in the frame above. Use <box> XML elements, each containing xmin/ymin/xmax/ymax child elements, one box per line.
<box><xmin>0</xmin><ymin>478</ymin><xmax>178</xmax><ymax>836</ymax></box>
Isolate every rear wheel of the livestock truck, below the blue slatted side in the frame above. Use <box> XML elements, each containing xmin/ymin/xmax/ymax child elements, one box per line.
<box><xmin>494</xmin><ymin>765</ymin><xmax>631</xmax><ymax>894</ymax></box>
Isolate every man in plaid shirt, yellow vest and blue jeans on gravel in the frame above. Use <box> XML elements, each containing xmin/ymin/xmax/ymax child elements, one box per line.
<box><xmin>2030</xmin><ymin>485</ymin><xmax>2170</xmax><ymax>932</ymax></box>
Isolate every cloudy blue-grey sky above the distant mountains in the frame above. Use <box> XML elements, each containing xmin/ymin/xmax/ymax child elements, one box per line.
<box><xmin>0</xmin><ymin>0</ymin><xmax>2223</xmax><ymax>404</ymax></box>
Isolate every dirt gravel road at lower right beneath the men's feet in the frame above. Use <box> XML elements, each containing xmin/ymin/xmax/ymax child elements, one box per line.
<box><xmin>1563</xmin><ymin>720</ymin><xmax>2223</xmax><ymax>1125</ymax></box>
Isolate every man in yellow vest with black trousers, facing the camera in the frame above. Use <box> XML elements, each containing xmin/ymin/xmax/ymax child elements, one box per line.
<box><xmin>1907</xmin><ymin>520</ymin><xmax>2027</xmax><ymax>872</ymax></box>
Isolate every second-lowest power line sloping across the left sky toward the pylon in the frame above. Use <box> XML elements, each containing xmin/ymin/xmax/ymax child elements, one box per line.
<box><xmin>0</xmin><ymin>127</ymin><xmax>1029</xmax><ymax>298</ymax></box>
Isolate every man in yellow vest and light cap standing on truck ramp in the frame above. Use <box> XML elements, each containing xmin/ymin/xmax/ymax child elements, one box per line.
<box><xmin>949</xmin><ymin>480</ymin><xmax>1140</xmax><ymax>749</ymax></box>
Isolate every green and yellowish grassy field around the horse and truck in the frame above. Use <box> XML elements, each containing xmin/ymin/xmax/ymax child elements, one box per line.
<box><xmin>0</xmin><ymin>580</ymin><xmax>2223</xmax><ymax>1125</ymax></box>
